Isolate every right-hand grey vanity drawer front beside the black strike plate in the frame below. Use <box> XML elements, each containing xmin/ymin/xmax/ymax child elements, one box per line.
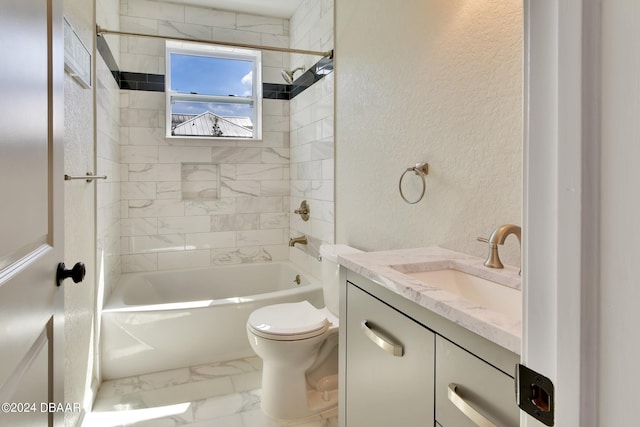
<box><xmin>435</xmin><ymin>336</ymin><xmax>520</xmax><ymax>427</ymax></box>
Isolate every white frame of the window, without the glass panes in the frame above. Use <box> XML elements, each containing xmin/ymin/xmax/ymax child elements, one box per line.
<box><xmin>165</xmin><ymin>40</ymin><xmax>262</xmax><ymax>141</ymax></box>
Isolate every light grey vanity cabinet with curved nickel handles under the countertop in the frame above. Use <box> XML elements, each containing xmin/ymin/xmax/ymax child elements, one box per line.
<box><xmin>339</xmin><ymin>269</ymin><xmax>520</xmax><ymax>427</ymax></box>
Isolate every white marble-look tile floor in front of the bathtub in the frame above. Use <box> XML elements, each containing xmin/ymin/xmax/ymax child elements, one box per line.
<box><xmin>90</xmin><ymin>357</ymin><xmax>338</xmax><ymax>427</ymax></box>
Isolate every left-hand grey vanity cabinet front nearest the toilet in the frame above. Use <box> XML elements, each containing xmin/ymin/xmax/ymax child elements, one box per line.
<box><xmin>340</xmin><ymin>284</ymin><xmax>435</xmax><ymax>427</ymax></box>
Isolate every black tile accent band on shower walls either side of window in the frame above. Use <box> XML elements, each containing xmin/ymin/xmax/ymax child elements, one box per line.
<box><xmin>96</xmin><ymin>35</ymin><xmax>333</xmax><ymax>101</ymax></box>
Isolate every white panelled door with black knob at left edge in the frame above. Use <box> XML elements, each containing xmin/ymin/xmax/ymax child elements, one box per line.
<box><xmin>0</xmin><ymin>0</ymin><xmax>64</xmax><ymax>426</ymax></box>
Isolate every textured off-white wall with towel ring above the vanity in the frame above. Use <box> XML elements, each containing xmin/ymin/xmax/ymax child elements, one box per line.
<box><xmin>336</xmin><ymin>0</ymin><xmax>522</xmax><ymax>265</ymax></box>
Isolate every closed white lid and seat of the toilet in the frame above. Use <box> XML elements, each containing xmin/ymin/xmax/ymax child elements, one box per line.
<box><xmin>247</xmin><ymin>301</ymin><xmax>329</xmax><ymax>339</ymax></box>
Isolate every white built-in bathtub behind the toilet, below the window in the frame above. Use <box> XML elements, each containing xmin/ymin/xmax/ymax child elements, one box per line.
<box><xmin>100</xmin><ymin>262</ymin><xmax>323</xmax><ymax>379</ymax></box>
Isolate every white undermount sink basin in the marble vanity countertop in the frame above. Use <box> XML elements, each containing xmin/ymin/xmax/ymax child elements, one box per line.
<box><xmin>404</xmin><ymin>269</ymin><xmax>522</xmax><ymax>320</ymax></box>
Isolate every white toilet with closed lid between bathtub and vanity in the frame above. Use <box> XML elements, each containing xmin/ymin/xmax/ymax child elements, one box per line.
<box><xmin>247</xmin><ymin>245</ymin><xmax>361</xmax><ymax>419</ymax></box>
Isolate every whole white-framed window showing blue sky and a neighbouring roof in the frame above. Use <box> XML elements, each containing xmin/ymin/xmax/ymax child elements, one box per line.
<box><xmin>165</xmin><ymin>41</ymin><xmax>262</xmax><ymax>140</ymax></box>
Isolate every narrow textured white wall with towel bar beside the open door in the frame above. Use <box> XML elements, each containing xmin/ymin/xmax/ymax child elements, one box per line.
<box><xmin>64</xmin><ymin>0</ymin><xmax>96</xmax><ymax>425</ymax></box>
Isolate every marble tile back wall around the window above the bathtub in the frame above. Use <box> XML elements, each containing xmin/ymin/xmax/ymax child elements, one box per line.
<box><xmin>120</xmin><ymin>0</ymin><xmax>290</xmax><ymax>273</ymax></box>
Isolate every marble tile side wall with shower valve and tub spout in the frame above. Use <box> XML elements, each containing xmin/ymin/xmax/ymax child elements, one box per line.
<box><xmin>290</xmin><ymin>0</ymin><xmax>334</xmax><ymax>274</ymax></box>
